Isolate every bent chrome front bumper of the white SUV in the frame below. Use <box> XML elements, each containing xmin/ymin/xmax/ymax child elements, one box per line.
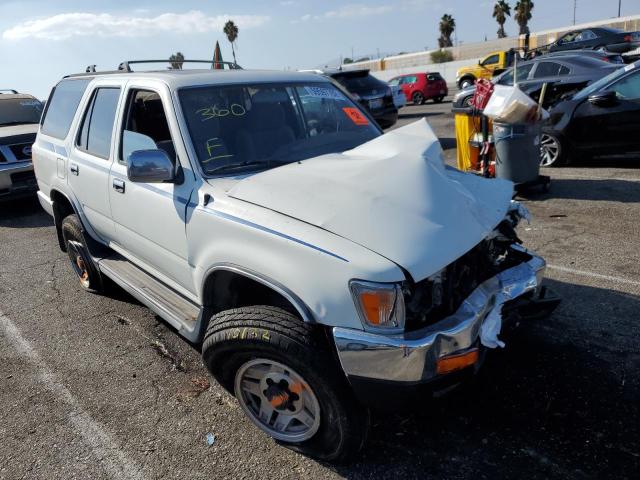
<box><xmin>333</xmin><ymin>253</ymin><xmax>558</xmax><ymax>394</ymax></box>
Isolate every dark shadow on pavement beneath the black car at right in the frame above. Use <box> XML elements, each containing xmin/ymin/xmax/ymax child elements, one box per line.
<box><xmin>540</xmin><ymin>179</ymin><xmax>640</xmax><ymax>203</ymax></box>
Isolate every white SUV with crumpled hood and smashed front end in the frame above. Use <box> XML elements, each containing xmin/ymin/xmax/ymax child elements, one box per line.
<box><xmin>33</xmin><ymin>61</ymin><xmax>557</xmax><ymax>461</ymax></box>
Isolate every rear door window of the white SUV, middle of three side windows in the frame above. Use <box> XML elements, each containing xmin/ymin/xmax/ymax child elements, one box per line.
<box><xmin>77</xmin><ymin>88</ymin><xmax>120</xmax><ymax>159</ymax></box>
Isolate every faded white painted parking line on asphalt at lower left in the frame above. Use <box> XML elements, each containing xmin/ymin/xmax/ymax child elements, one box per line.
<box><xmin>0</xmin><ymin>311</ymin><xmax>144</xmax><ymax>480</ymax></box>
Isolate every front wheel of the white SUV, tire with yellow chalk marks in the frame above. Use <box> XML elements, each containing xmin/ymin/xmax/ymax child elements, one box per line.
<box><xmin>202</xmin><ymin>306</ymin><xmax>369</xmax><ymax>462</ymax></box>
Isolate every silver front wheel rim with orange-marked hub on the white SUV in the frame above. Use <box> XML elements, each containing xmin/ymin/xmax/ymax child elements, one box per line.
<box><xmin>234</xmin><ymin>358</ymin><xmax>320</xmax><ymax>442</ymax></box>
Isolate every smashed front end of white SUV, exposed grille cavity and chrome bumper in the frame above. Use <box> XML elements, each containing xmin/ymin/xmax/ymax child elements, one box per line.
<box><xmin>333</xmin><ymin>202</ymin><xmax>560</xmax><ymax>407</ymax></box>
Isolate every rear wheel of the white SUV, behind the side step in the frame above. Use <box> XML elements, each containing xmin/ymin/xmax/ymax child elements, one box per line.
<box><xmin>60</xmin><ymin>214</ymin><xmax>103</xmax><ymax>293</ymax></box>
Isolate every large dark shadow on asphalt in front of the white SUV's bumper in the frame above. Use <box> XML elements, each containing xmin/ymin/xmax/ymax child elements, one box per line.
<box><xmin>337</xmin><ymin>281</ymin><xmax>640</xmax><ymax>479</ymax></box>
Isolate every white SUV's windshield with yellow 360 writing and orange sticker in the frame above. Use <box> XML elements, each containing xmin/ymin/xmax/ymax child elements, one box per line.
<box><xmin>179</xmin><ymin>82</ymin><xmax>380</xmax><ymax>175</ymax></box>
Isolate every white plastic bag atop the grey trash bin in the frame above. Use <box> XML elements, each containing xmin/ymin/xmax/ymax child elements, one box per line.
<box><xmin>484</xmin><ymin>85</ymin><xmax>538</xmax><ymax>124</ymax></box>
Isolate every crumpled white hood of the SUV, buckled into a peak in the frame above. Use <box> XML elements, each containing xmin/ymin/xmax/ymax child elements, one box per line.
<box><xmin>228</xmin><ymin>119</ymin><xmax>513</xmax><ymax>281</ymax></box>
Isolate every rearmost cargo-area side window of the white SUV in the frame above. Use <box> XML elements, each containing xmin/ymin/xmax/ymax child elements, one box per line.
<box><xmin>41</xmin><ymin>78</ymin><xmax>91</xmax><ymax>139</ymax></box>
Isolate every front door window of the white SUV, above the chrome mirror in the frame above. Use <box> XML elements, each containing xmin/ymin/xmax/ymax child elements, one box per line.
<box><xmin>118</xmin><ymin>90</ymin><xmax>176</xmax><ymax>164</ymax></box>
